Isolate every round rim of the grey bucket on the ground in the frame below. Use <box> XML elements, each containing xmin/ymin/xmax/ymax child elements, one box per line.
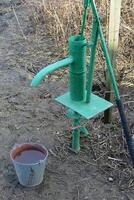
<box><xmin>10</xmin><ymin>142</ymin><xmax>48</xmax><ymax>166</ymax></box>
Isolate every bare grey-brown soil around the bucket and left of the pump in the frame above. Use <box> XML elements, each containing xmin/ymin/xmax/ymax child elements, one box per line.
<box><xmin>0</xmin><ymin>1</ymin><xmax>134</xmax><ymax>200</ymax></box>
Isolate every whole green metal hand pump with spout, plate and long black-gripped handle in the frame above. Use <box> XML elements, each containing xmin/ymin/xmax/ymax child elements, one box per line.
<box><xmin>31</xmin><ymin>0</ymin><xmax>134</xmax><ymax>165</ymax></box>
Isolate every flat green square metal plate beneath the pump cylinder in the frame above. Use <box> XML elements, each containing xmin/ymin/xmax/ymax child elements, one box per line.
<box><xmin>55</xmin><ymin>92</ymin><xmax>113</xmax><ymax>119</ymax></box>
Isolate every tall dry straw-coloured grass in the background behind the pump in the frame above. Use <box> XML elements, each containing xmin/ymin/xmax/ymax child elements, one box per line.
<box><xmin>27</xmin><ymin>0</ymin><xmax>134</xmax><ymax>85</ymax></box>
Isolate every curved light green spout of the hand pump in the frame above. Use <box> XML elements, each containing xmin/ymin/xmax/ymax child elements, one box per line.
<box><xmin>31</xmin><ymin>56</ymin><xmax>73</xmax><ymax>87</ymax></box>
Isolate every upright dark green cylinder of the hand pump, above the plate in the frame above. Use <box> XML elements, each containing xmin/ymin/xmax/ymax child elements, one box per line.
<box><xmin>69</xmin><ymin>35</ymin><xmax>87</xmax><ymax>101</ymax></box>
